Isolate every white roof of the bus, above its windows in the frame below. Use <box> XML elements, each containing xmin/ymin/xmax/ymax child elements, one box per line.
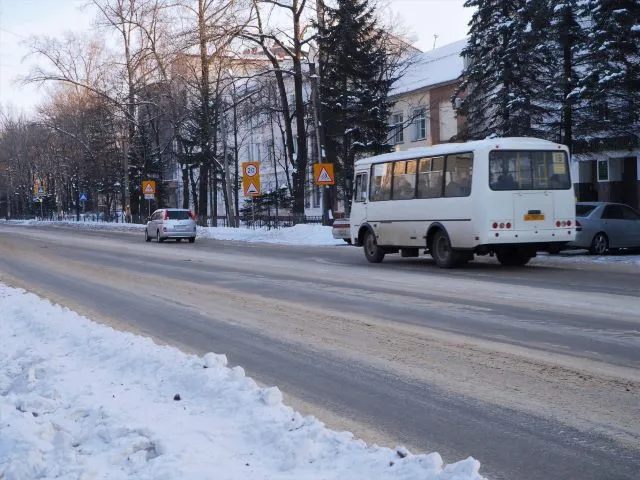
<box><xmin>355</xmin><ymin>137</ymin><xmax>567</xmax><ymax>167</ymax></box>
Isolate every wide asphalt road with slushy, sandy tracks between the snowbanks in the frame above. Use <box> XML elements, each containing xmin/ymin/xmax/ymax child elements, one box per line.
<box><xmin>0</xmin><ymin>225</ymin><xmax>640</xmax><ymax>480</ymax></box>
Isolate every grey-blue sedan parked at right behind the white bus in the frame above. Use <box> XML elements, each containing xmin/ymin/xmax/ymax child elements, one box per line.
<box><xmin>568</xmin><ymin>202</ymin><xmax>640</xmax><ymax>255</ymax></box>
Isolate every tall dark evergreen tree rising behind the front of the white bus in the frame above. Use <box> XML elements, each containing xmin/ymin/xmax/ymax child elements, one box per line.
<box><xmin>318</xmin><ymin>0</ymin><xmax>394</xmax><ymax>211</ymax></box>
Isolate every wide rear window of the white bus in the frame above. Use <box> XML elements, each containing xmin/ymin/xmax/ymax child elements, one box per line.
<box><xmin>489</xmin><ymin>150</ymin><xmax>571</xmax><ymax>190</ymax></box>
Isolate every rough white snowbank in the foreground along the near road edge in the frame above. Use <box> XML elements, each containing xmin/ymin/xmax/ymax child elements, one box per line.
<box><xmin>0</xmin><ymin>284</ymin><xmax>483</xmax><ymax>480</ymax></box>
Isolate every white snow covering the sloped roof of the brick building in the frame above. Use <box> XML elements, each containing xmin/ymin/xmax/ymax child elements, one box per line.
<box><xmin>390</xmin><ymin>38</ymin><xmax>467</xmax><ymax>96</ymax></box>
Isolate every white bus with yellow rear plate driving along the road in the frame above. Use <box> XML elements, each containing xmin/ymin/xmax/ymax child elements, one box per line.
<box><xmin>350</xmin><ymin>137</ymin><xmax>576</xmax><ymax>268</ymax></box>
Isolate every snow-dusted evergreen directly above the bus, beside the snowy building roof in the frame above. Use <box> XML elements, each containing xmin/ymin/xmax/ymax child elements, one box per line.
<box><xmin>453</xmin><ymin>0</ymin><xmax>550</xmax><ymax>139</ymax></box>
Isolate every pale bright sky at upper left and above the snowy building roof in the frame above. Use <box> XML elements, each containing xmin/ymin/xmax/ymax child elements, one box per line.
<box><xmin>0</xmin><ymin>0</ymin><xmax>471</xmax><ymax>113</ymax></box>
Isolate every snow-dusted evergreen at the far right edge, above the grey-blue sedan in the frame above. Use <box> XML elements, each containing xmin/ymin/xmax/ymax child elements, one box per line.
<box><xmin>581</xmin><ymin>0</ymin><xmax>640</xmax><ymax>150</ymax></box>
